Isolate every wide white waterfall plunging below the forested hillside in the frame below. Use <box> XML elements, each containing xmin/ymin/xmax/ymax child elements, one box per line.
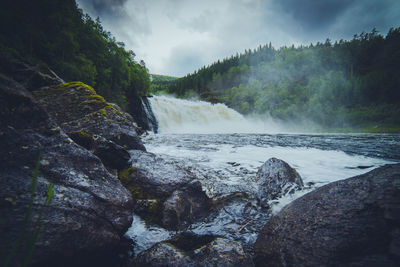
<box><xmin>149</xmin><ymin>96</ymin><xmax>278</xmax><ymax>134</ymax></box>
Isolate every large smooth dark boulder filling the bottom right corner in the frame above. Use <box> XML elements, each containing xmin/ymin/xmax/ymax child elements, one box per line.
<box><xmin>255</xmin><ymin>164</ymin><xmax>400</xmax><ymax>266</ymax></box>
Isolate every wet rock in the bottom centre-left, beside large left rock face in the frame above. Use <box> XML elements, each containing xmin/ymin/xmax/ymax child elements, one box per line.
<box><xmin>119</xmin><ymin>150</ymin><xmax>210</xmax><ymax>229</ymax></box>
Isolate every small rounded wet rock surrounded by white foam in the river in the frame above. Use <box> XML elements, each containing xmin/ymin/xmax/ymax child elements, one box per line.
<box><xmin>255</xmin><ymin>158</ymin><xmax>303</xmax><ymax>201</ymax></box>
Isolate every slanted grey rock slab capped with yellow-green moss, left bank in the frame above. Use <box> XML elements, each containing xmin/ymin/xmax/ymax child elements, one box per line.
<box><xmin>33</xmin><ymin>82</ymin><xmax>145</xmax><ymax>153</ymax></box>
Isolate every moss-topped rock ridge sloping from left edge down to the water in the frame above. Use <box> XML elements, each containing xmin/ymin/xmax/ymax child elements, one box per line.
<box><xmin>0</xmin><ymin>52</ymin><xmax>146</xmax><ymax>174</ymax></box>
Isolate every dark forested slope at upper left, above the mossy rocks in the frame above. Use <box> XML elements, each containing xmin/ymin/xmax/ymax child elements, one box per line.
<box><xmin>0</xmin><ymin>0</ymin><xmax>150</xmax><ymax>112</ymax></box>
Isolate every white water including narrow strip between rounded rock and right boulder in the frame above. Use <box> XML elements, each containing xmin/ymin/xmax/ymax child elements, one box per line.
<box><xmin>145</xmin><ymin>135</ymin><xmax>393</xmax><ymax>213</ymax></box>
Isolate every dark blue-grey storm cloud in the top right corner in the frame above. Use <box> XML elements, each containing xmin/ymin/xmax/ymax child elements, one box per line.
<box><xmin>273</xmin><ymin>0</ymin><xmax>400</xmax><ymax>38</ymax></box>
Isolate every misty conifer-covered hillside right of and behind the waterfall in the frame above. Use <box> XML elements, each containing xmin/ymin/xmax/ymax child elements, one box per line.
<box><xmin>158</xmin><ymin>28</ymin><xmax>400</xmax><ymax>131</ymax></box>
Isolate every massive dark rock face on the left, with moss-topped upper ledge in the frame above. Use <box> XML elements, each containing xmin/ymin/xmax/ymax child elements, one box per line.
<box><xmin>0</xmin><ymin>56</ymin><xmax>139</xmax><ymax>265</ymax></box>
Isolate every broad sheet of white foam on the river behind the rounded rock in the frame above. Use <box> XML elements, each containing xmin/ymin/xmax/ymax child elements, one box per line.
<box><xmin>146</xmin><ymin>140</ymin><xmax>389</xmax><ymax>193</ymax></box>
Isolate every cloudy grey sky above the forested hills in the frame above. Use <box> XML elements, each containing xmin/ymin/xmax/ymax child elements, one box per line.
<box><xmin>77</xmin><ymin>0</ymin><xmax>400</xmax><ymax>76</ymax></box>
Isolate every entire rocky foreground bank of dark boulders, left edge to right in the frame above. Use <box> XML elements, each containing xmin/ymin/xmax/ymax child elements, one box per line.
<box><xmin>0</xmin><ymin>56</ymin><xmax>400</xmax><ymax>266</ymax></box>
